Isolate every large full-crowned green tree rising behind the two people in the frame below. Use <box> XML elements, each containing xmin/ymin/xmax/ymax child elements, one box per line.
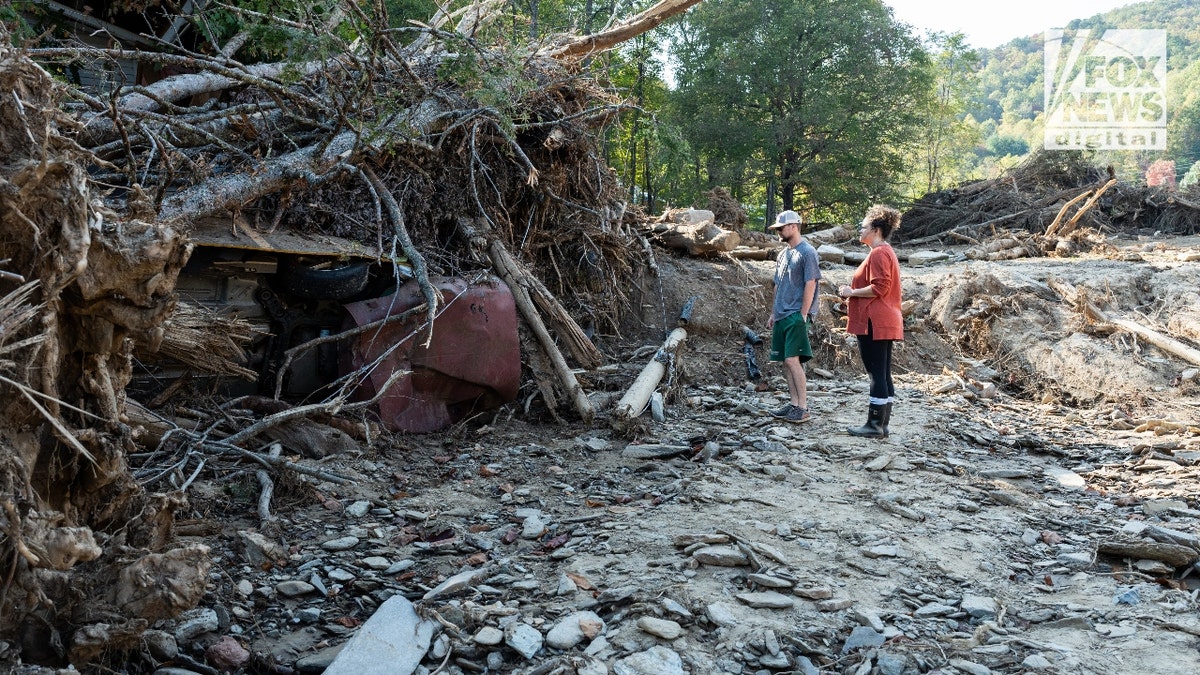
<box><xmin>674</xmin><ymin>0</ymin><xmax>931</xmax><ymax>215</ymax></box>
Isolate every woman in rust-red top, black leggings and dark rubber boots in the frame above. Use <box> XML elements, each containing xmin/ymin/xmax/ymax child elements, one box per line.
<box><xmin>838</xmin><ymin>205</ymin><xmax>904</xmax><ymax>438</ymax></box>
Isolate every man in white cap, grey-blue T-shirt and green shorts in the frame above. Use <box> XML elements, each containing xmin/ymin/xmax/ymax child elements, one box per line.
<box><xmin>767</xmin><ymin>210</ymin><xmax>821</xmax><ymax>423</ymax></box>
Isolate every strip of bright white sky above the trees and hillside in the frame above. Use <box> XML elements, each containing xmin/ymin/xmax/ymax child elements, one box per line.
<box><xmin>884</xmin><ymin>0</ymin><xmax>1134</xmax><ymax>49</ymax></box>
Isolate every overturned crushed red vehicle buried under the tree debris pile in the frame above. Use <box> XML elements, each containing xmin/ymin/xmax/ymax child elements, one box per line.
<box><xmin>156</xmin><ymin>221</ymin><xmax>521</xmax><ymax>432</ymax></box>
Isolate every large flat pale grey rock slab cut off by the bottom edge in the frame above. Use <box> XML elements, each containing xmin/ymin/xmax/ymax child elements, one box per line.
<box><xmin>324</xmin><ymin>596</ymin><xmax>436</xmax><ymax>675</ymax></box>
